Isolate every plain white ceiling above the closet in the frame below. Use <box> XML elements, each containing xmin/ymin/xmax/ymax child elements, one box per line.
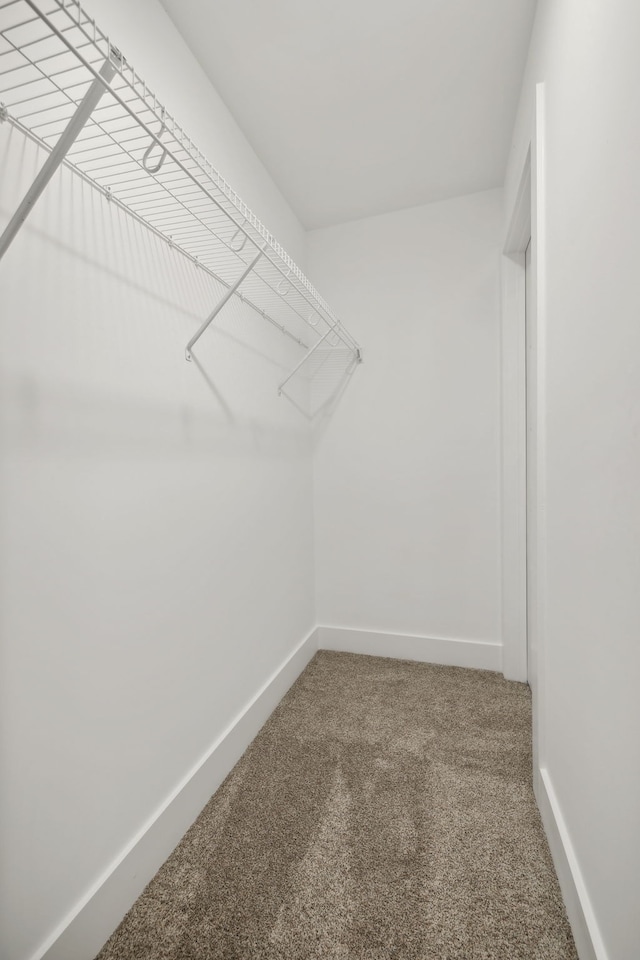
<box><xmin>161</xmin><ymin>0</ymin><xmax>536</xmax><ymax>229</ymax></box>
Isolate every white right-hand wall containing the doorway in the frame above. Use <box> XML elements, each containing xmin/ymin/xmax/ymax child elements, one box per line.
<box><xmin>506</xmin><ymin>0</ymin><xmax>640</xmax><ymax>960</ymax></box>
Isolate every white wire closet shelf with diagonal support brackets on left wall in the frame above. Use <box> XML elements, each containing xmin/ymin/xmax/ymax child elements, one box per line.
<box><xmin>0</xmin><ymin>0</ymin><xmax>361</xmax><ymax>392</ymax></box>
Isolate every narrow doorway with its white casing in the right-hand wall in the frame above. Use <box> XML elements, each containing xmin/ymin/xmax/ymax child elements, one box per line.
<box><xmin>501</xmin><ymin>85</ymin><xmax>545</xmax><ymax>789</ymax></box>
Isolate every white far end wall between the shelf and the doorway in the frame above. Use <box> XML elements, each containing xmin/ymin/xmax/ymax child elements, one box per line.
<box><xmin>308</xmin><ymin>191</ymin><xmax>502</xmax><ymax>643</ymax></box>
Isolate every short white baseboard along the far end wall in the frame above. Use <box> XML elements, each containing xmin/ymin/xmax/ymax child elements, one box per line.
<box><xmin>318</xmin><ymin>627</ymin><xmax>502</xmax><ymax>671</ymax></box>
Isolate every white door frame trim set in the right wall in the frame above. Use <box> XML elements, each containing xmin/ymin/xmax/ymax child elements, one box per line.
<box><xmin>501</xmin><ymin>83</ymin><xmax>546</xmax><ymax>790</ymax></box>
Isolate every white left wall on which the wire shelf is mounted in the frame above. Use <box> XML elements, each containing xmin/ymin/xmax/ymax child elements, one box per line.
<box><xmin>0</xmin><ymin>0</ymin><xmax>315</xmax><ymax>960</ymax></box>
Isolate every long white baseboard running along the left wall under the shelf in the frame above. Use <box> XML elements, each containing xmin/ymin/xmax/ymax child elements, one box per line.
<box><xmin>31</xmin><ymin>630</ymin><xmax>318</xmax><ymax>960</ymax></box>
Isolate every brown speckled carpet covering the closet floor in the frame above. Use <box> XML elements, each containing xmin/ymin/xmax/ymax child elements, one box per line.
<box><xmin>99</xmin><ymin>651</ymin><xmax>577</xmax><ymax>960</ymax></box>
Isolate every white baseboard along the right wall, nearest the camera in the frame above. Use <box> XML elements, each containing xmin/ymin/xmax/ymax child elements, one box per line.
<box><xmin>536</xmin><ymin>767</ymin><xmax>609</xmax><ymax>960</ymax></box>
